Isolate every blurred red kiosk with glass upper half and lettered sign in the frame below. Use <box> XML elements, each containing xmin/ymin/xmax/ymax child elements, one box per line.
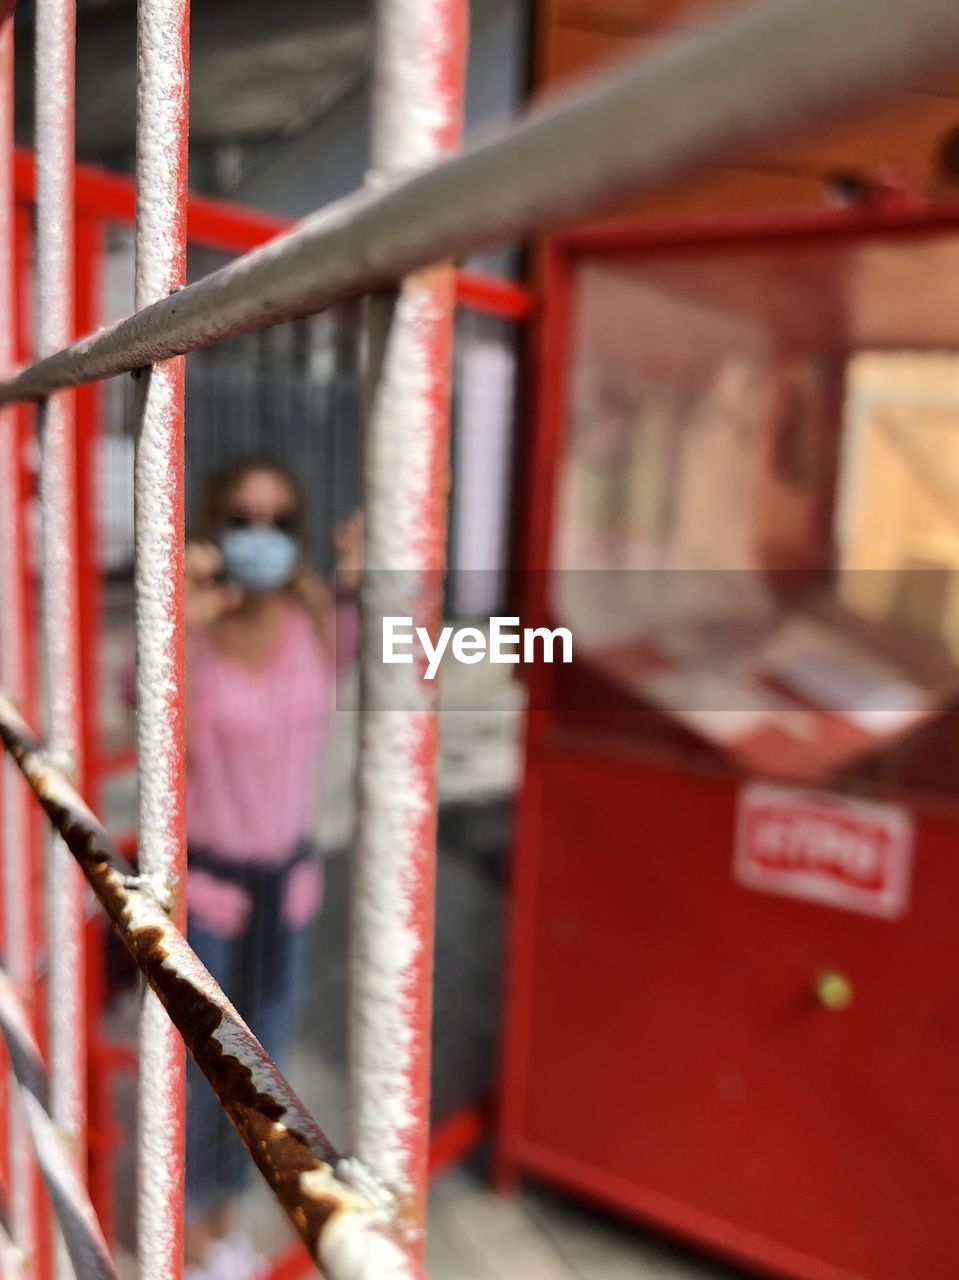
<box><xmin>498</xmin><ymin>198</ymin><xmax>959</xmax><ymax>1280</ymax></box>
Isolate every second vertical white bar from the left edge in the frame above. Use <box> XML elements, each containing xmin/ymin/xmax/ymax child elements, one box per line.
<box><xmin>35</xmin><ymin>0</ymin><xmax>86</xmax><ymax>1277</ymax></box>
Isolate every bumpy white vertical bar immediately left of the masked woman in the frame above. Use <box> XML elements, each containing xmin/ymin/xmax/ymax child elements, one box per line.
<box><xmin>134</xmin><ymin>0</ymin><xmax>189</xmax><ymax>1280</ymax></box>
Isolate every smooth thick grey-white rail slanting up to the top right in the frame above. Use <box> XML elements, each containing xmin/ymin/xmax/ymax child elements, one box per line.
<box><xmin>0</xmin><ymin>0</ymin><xmax>959</xmax><ymax>403</ymax></box>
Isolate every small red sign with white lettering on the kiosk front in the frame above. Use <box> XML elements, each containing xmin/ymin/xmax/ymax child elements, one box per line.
<box><xmin>735</xmin><ymin>782</ymin><xmax>913</xmax><ymax>916</ymax></box>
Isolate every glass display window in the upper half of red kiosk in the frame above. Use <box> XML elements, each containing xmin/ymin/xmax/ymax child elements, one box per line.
<box><xmin>551</xmin><ymin>237</ymin><xmax>959</xmax><ymax>794</ymax></box>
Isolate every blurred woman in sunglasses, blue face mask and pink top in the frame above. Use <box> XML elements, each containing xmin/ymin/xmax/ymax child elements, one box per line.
<box><xmin>184</xmin><ymin>461</ymin><xmax>361</xmax><ymax>1280</ymax></box>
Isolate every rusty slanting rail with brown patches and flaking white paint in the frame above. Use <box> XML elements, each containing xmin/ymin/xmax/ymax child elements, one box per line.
<box><xmin>0</xmin><ymin>694</ymin><xmax>420</xmax><ymax>1280</ymax></box>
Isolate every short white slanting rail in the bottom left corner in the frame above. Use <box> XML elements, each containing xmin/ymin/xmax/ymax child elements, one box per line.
<box><xmin>0</xmin><ymin>970</ymin><xmax>117</xmax><ymax>1280</ymax></box>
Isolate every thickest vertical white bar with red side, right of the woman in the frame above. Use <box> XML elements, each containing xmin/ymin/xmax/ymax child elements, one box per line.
<box><xmin>350</xmin><ymin>0</ymin><xmax>469</xmax><ymax>1247</ymax></box>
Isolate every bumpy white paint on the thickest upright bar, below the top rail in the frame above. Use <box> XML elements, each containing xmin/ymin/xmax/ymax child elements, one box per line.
<box><xmin>351</xmin><ymin>280</ymin><xmax>446</xmax><ymax>1198</ymax></box>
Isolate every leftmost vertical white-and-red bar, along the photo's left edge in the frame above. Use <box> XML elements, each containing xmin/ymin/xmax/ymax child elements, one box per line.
<box><xmin>0</xmin><ymin>10</ymin><xmax>37</xmax><ymax>1265</ymax></box>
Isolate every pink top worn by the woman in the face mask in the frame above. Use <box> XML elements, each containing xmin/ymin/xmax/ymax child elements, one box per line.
<box><xmin>187</xmin><ymin>605</ymin><xmax>356</xmax><ymax>864</ymax></box>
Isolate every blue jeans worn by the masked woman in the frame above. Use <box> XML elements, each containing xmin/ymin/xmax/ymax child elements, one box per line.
<box><xmin>186</xmin><ymin>855</ymin><xmax>310</xmax><ymax>1216</ymax></box>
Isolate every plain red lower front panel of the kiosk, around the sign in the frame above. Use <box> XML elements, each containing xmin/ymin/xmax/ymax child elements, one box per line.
<box><xmin>513</xmin><ymin>751</ymin><xmax>959</xmax><ymax>1280</ymax></box>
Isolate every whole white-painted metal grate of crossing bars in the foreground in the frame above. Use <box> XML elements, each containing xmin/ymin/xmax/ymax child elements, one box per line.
<box><xmin>0</xmin><ymin>0</ymin><xmax>959</xmax><ymax>1280</ymax></box>
